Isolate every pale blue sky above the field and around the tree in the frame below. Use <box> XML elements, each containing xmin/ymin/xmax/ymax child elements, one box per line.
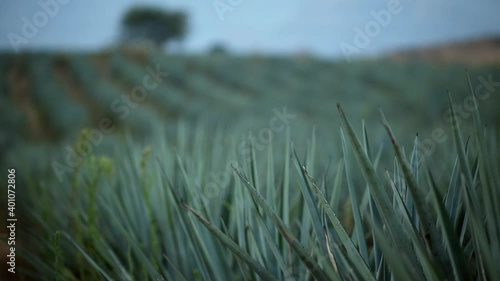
<box><xmin>0</xmin><ymin>0</ymin><xmax>500</xmax><ymax>58</ymax></box>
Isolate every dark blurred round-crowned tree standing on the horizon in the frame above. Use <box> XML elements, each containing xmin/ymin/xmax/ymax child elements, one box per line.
<box><xmin>122</xmin><ymin>7</ymin><xmax>187</xmax><ymax>46</ymax></box>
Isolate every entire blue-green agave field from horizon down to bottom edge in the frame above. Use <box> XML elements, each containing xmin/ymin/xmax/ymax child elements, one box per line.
<box><xmin>0</xmin><ymin>49</ymin><xmax>500</xmax><ymax>280</ymax></box>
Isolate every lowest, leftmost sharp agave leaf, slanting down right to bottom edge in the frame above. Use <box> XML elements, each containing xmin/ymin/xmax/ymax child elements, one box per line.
<box><xmin>182</xmin><ymin>203</ymin><xmax>278</xmax><ymax>280</ymax></box>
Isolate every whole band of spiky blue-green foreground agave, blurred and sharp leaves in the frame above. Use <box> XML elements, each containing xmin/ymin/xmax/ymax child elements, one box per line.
<box><xmin>17</xmin><ymin>73</ymin><xmax>500</xmax><ymax>280</ymax></box>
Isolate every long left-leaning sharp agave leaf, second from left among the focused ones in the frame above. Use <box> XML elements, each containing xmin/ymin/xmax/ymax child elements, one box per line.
<box><xmin>233</xmin><ymin>166</ymin><xmax>330</xmax><ymax>280</ymax></box>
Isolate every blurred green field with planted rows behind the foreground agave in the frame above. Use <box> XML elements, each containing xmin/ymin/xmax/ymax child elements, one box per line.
<box><xmin>1</xmin><ymin>47</ymin><xmax>500</xmax><ymax>173</ymax></box>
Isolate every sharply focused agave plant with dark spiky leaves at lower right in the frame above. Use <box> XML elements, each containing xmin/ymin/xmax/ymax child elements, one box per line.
<box><xmin>181</xmin><ymin>74</ymin><xmax>500</xmax><ymax>280</ymax></box>
